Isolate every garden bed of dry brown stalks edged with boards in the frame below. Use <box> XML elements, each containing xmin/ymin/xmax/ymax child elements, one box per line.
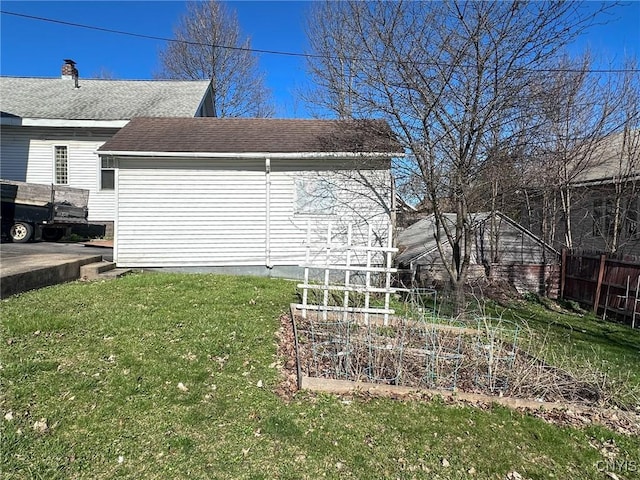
<box><xmin>292</xmin><ymin>310</ymin><xmax>602</xmax><ymax>405</ymax></box>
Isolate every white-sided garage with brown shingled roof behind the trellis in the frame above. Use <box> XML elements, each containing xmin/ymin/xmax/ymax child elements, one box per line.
<box><xmin>98</xmin><ymin>118</ymin><xmax>401</xmax><ymax>276</ymax></box>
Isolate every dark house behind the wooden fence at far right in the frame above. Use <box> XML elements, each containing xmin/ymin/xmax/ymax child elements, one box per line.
<box><xmin>522</xmin><ymin>130</ymin><xmax>640</xmax><ymax>256</ymax></box>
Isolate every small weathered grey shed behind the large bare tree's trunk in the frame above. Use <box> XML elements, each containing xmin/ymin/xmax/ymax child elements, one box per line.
<box><xmin>396</xmin><ymin>212</ymin><xmax>560</xmax><ymax>296</ymax></box>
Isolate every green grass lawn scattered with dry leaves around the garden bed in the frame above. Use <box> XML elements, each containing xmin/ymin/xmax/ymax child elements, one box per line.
<box><xmin>0</xmin><ymin>274</ymin><xmax>640</xmax><ymax>479</ymax></box>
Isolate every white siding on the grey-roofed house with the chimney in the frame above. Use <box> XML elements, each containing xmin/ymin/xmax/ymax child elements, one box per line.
<box><xmin>0</xmin><ymin>126</ymin><xmax>116</xmax><ymax>222</ymax></box>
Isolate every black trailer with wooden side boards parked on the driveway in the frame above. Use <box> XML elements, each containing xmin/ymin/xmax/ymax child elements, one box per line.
<box><xmin>0</xmin><ymin>180</ymin><xmax>89</xmax><ymax>243</ymax></box>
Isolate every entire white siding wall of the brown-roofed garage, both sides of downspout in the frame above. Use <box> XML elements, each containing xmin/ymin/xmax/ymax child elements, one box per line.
<box><xmin>114</xmin><ymin>158</ymin><xmax>390</xmax><ymax>267</ymax></box>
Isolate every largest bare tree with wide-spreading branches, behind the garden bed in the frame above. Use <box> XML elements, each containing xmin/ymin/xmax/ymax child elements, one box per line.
<box><xmin>304</xmin><ymin>0</ymin><xmax>610</xmax><ymax>311</ymax></box>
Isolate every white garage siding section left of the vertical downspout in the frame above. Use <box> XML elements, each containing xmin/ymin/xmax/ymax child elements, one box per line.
<box><xmin>114</xmin><ymin>159</ymin><xmax>266</xmax><ymax>267</ymax></box>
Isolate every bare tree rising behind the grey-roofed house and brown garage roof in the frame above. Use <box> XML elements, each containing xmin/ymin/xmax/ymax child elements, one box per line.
<box><xmin>157</xmin><ymin>0</ymin><xmax>274</xmax><ymax>117</ymax></box>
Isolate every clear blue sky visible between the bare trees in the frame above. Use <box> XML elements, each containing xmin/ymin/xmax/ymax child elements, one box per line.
<box><xmin>0</xmin><ymin>0</ymin><xmax>640</xmax><ymax>117</ymax></box>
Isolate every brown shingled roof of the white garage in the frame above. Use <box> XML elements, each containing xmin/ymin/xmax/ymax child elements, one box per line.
<box><xmin>99</xmin><ymin>117</ymin><xmax>402</xmax><ymax>154</ymax></box>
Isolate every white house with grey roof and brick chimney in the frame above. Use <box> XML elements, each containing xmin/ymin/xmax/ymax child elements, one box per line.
<box><xmin>0</xmin><ymin>60</ymin><xmax>212</xmax><ymax>235</ymax></box>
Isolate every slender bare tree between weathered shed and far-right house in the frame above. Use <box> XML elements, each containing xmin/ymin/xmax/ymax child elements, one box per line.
<box><xmin>523</xmin><ymin>54</ymin><xmax>617</xmax><ymax>248</ymax></box>
